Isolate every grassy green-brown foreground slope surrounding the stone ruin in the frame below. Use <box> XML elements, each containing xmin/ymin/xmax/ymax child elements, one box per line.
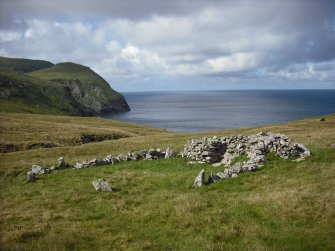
<box><xmin>0</xmin><ymin>114</ymin><xmax>335</xmax><ymax>250</ymax></box>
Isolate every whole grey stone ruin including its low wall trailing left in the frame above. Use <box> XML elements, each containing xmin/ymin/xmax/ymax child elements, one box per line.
<box><xmin>26</xmin><ymin>132</ymin><xmax>311</xmax><ymax>191</ymax></box>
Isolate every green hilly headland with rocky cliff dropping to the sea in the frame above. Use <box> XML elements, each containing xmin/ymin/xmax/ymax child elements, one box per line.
<box><xmin>0</xmin><ymin>57</ymin><xmax>130</xmax><ymax>116</ymax></box>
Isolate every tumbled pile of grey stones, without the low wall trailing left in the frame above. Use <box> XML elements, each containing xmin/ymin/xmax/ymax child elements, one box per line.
<box><xmin>189</xmin><ymin>132</ymin><xmax>311</xmax><ymax>188</ymax></box>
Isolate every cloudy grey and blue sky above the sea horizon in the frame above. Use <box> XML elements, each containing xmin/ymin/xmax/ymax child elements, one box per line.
<box><xmin>0</xmin><ymin>0</ymin><xmax>335</xmax><ymax>92</ymax></box>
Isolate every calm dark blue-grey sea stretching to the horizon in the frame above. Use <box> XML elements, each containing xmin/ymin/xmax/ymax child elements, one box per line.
<box><xmin>105</xmin><ymin>90</ymin><xmax>335</xmax><ymax>132</ymax></box>
